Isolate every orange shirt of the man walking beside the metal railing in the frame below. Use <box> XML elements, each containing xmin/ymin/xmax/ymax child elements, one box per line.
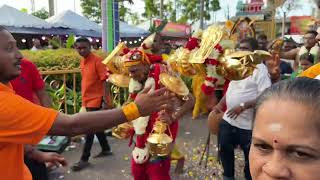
<box><xmin>80</xmin><ymin>53</ymin><xmax>108</xmax><ymax>108</ymax></box>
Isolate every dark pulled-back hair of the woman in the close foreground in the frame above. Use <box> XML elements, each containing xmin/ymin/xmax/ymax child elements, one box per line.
<box><xmin>255</xmin><ymin>78</ymin><xmax>320</xmax><ymax>125</ymax></box>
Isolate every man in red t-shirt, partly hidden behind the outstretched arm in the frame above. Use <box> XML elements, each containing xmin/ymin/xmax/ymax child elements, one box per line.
<box><xmin>10</xmin><ymin>58</ymin><xmax>66</xmax><ymax>180</ymax></box>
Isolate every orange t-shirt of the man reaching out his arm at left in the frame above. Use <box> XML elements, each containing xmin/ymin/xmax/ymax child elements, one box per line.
<box><xmin>0</xmin><ymin>83</ymin><xmax>58</xmax><ymax>180</ymax></box>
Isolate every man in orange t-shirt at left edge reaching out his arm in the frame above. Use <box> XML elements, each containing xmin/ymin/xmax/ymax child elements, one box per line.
<box><xmin>0</xmin><ymin>26</ymin><xmax>174</xmax><ymax>180</ymax></box>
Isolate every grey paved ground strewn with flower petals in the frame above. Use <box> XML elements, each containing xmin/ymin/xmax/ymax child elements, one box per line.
<box><xmin>50</xmin><ymin>115</ymin><xmax>243</xmax><ymax>180</ymax></box>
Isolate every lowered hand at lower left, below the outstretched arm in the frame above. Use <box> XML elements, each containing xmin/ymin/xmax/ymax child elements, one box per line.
<box><xmin>36</xmin><ymin>151</ymin><xmax>67</xmax><ymax>167</ymax></box>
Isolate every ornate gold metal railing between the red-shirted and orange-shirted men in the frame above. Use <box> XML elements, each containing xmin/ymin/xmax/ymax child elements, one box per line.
<box><xmin>40</xmin><ymin>69</ymin><xmax>80</xmax><ymax>114</ymax></box>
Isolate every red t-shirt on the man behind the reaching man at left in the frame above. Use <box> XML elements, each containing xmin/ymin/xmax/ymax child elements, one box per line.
<box><xmin>11</xmin><ymin>59</ymin><xmax>45</xmax><ymax>103</ymax></box>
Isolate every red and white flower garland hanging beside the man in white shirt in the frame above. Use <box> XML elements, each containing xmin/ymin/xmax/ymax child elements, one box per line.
<box><xmin>201</xmin><ymin>44</ymin><xmax>223</xmax><ymax>96</ymax></box>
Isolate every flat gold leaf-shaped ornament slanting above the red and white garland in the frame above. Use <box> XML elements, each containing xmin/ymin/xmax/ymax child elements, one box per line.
<box><xmin>190</xmin><ymin>25</ymin><xmax>225</xmax><ymax>64</ymax></box>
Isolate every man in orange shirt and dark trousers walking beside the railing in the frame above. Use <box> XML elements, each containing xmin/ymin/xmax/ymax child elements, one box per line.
<box><xmin>72</xmin><ymin>38</ymin><xmax>112</xmax><ymax>171</ymax></box>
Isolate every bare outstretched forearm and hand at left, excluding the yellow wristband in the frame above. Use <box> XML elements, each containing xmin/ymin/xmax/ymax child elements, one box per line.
<box><xmin>48</xmin><ymin>89</ymin><xmax>174</xmax><ymax>136</ymax></box>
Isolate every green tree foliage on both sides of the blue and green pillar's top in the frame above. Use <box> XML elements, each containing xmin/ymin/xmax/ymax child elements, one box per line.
<box><xmin>80</xmin><ymin>0</ymin><xmax>133</xmax><ymax>23</ymax></box>
